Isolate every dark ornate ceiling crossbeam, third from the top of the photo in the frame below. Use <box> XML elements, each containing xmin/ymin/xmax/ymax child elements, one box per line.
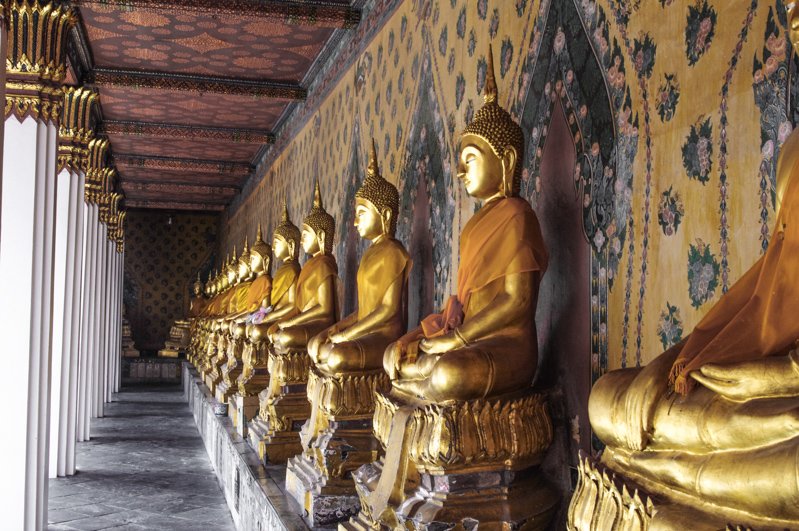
<box><xmin>100</xmin><ymin>120</ymin><xmax>275</xmax><ymax>144</ymax></box>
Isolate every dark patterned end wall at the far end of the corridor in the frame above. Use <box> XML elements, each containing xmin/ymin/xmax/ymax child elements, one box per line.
<box><xmin>124</xmin><ymin>210</ymin><xmax>218</xmax><ymax>350</ymax></box>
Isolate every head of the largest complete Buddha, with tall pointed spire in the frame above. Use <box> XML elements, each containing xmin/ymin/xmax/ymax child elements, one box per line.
<box><xmin>458</xmin><ymin>45</ymin><xmax>524</xmax><ymax>201</ymax></box>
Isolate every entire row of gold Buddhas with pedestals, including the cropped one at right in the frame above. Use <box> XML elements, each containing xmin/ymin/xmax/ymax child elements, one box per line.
<box><xmin>184</xmin><ymin>41</ymin><xmax>799</xmax><ymax>531</ymax></box>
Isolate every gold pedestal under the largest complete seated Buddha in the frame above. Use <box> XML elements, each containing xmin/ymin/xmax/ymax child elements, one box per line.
<box><xmin>339</xmin><ymin>389</ymin><xmax>559</xmax><ymax>531</ymax></box>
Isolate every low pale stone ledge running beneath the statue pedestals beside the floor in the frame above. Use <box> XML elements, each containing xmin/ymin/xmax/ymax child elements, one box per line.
<box><xmin>183</xmin><ymin>363</ymin><xmax>309</xmax><ymax>531</ymax></box>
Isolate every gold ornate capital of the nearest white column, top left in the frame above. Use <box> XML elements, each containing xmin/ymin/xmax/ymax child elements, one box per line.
<box><xmin>5</xmin><ymin>0</ymin><xmax>76</xmax><ymax>123</ymax></box>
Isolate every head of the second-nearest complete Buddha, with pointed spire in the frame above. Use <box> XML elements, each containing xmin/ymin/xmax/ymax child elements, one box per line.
<box><xmin>355</xmin><ymin>138</ymin><xmax>399</xmax><ymax>241</ymax></box>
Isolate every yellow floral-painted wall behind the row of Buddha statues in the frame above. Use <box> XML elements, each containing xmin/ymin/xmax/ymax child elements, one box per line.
<box><xmin>217</xmin><ymin>0</ymin><xmax>796</xmax><ymax>378</ymax></box>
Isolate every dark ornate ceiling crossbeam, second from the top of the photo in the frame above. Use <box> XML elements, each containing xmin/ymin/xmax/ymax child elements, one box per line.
<box><xmin>86</xmin><ymin>68</ymin><xmax>308</xmax><ymax>100</ymax></box>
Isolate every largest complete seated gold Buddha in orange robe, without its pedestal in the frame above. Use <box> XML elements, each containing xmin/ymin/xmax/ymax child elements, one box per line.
<box><xmin>384</xmin><ymin>53</ymin><xmax>547</xmax><ymax>402</ymax></box>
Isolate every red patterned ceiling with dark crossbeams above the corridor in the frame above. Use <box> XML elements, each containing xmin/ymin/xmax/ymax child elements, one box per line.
<box><xmin>67</xmin><ymin>0</ymin><xmax>360</xmax><ymax>211</ymax></box>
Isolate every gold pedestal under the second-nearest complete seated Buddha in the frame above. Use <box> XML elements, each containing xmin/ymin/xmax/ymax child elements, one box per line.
<box><xmin>286</xmin><ymin>367</ymin><xmax>389</xmax><ymax>527</ymax></box>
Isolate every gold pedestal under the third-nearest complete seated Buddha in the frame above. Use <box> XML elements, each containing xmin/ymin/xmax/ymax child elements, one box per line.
<box><xmin>247</xmin><ymin>349</ymin><xmax>311</xmax><ymax>464</ymax></box>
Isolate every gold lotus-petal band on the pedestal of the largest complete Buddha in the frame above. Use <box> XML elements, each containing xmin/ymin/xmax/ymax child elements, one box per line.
<box><xmin>374</xmin><ymin>391</ymin><xmax>553</xmax><ymax>474</ymax></box>
